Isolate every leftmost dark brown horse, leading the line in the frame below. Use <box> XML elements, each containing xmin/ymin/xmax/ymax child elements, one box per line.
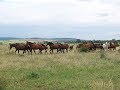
<box><xmin>9</xmin><ymin>43</ymin><xmax>30</xmax><ymax>54</ymax></box>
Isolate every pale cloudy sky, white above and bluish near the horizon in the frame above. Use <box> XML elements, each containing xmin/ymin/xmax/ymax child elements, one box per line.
<box><xmin>0</xmin><ymin>0</ymin><xmax>120</xmax><ymax>39</ymax></box>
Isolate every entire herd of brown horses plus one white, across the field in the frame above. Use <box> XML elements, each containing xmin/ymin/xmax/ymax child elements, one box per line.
<box><xmin>9</xmin><ymin>41</ymin><xmax>119</xmax><ymax>54</ymax></box>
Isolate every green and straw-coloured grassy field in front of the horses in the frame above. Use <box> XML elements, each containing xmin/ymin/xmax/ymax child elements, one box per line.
<box><xmin>0</xmin><ymin>45</ymin><xmax>120</xmax><ymax>90</ymax></box>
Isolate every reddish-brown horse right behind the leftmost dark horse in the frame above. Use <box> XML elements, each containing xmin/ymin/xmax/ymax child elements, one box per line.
<box><xmin>27</xmin><ymin>41</ymin><xmax>47</xmax><ymax>54</ymax></box>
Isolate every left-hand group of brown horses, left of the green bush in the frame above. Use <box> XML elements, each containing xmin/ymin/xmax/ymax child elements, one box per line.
<box><xmin>9</xmin><ymin>41</ymin><xmax>69</xmax><ymax>54</ymax></box>
